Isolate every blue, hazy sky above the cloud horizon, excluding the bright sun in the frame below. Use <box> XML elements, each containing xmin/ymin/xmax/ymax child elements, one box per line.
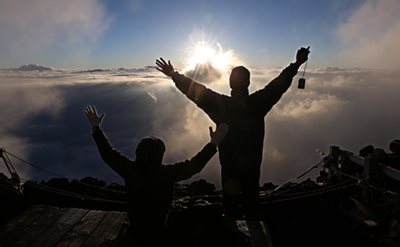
<box><xmin>0</xmin><ymin>0</ymin><xmax>400</xmax><ymax>69</ymax></box>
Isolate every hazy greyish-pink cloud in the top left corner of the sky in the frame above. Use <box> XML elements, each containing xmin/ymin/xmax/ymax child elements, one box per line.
<box><xmin>0</xmin><ymin>0</ymin><xmax>112</xmax><ymax>63</ymax></box>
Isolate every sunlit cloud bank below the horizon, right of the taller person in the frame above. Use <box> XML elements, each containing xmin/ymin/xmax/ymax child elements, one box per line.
<box><xmin>256</xmin><ymin>68</ymin><xmax>400</xmax><ymax>183</ymax></box>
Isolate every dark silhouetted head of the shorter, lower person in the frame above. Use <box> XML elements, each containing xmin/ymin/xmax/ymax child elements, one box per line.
<box><xmin>136</xmin><ymin>136</ymin><xmax>165</xmax><ymax>165</ymax></box>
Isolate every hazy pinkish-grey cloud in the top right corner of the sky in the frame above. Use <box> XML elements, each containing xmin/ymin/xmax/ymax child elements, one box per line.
<box><xmin>336</xmin><ymin>0</ymin><xmax>400</xmax><ymax>69</ymax></box>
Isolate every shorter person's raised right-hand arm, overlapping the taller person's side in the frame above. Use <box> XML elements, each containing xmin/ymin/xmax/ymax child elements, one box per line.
<box><xmin>167</xmin><ymin>123</ymin><xmax>229</xmax><ymax>182</ymax></box>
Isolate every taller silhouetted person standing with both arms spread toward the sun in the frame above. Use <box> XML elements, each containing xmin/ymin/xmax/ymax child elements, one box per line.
<box><xmin>156</xmin><ymin>48</ymin><xmax>309</xmax><ymax>222</ymax></box>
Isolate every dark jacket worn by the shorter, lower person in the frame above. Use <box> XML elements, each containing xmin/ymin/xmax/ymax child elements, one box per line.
<box><xmin>93</xmin><ymin>128</ymin><xmax>217</xmax><ymax>229</ymax></box>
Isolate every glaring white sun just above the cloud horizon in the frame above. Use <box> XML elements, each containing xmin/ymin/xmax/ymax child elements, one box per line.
<box><xmin>186</xmin><ymin>41</ymin><xmax>232</xmax><ymax>70</ymax></box>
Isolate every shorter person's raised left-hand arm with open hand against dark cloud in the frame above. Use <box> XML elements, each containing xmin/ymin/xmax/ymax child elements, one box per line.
<box><xmin>85</xmin><ymin>106</ymin><xmax>131</xmax><ymax>177</ymax></box>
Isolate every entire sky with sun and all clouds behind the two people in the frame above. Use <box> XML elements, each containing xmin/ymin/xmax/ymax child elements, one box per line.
<box><xmin>0</xmin><ymin>0</ymin><xmax>400</xmax><ymax>187</ymax></box>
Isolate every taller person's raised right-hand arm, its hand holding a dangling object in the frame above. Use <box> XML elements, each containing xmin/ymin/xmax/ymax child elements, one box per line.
<box><xmin>254</xmin><ymin>47</ymin><xmax>310</xmax><ymax>114</ymax></box>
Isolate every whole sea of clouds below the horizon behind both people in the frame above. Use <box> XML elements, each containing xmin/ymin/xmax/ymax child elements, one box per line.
<box><xmin>0</xmin><ymin>68</ymin><xmax>400</xmax><ymax>187</ymax></box>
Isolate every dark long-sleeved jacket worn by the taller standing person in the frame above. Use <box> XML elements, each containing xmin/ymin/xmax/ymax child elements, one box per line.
<box><xmin>172</xmin><ymin>64</ymin><xmax>298</xmax><ymax>169</ymax></box>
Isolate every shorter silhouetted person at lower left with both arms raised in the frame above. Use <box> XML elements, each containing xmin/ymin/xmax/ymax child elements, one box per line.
<box><xmin>85</xmin><ymin>106</ymin><xmax>228</xmax><ymax>246</ymax></box>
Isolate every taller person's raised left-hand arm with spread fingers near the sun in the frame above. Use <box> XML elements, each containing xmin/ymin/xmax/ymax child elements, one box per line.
<box><xmin>156</xmin><ymin>58</ymin><xmax>222</xmax><ymax>114</ymax></box>
